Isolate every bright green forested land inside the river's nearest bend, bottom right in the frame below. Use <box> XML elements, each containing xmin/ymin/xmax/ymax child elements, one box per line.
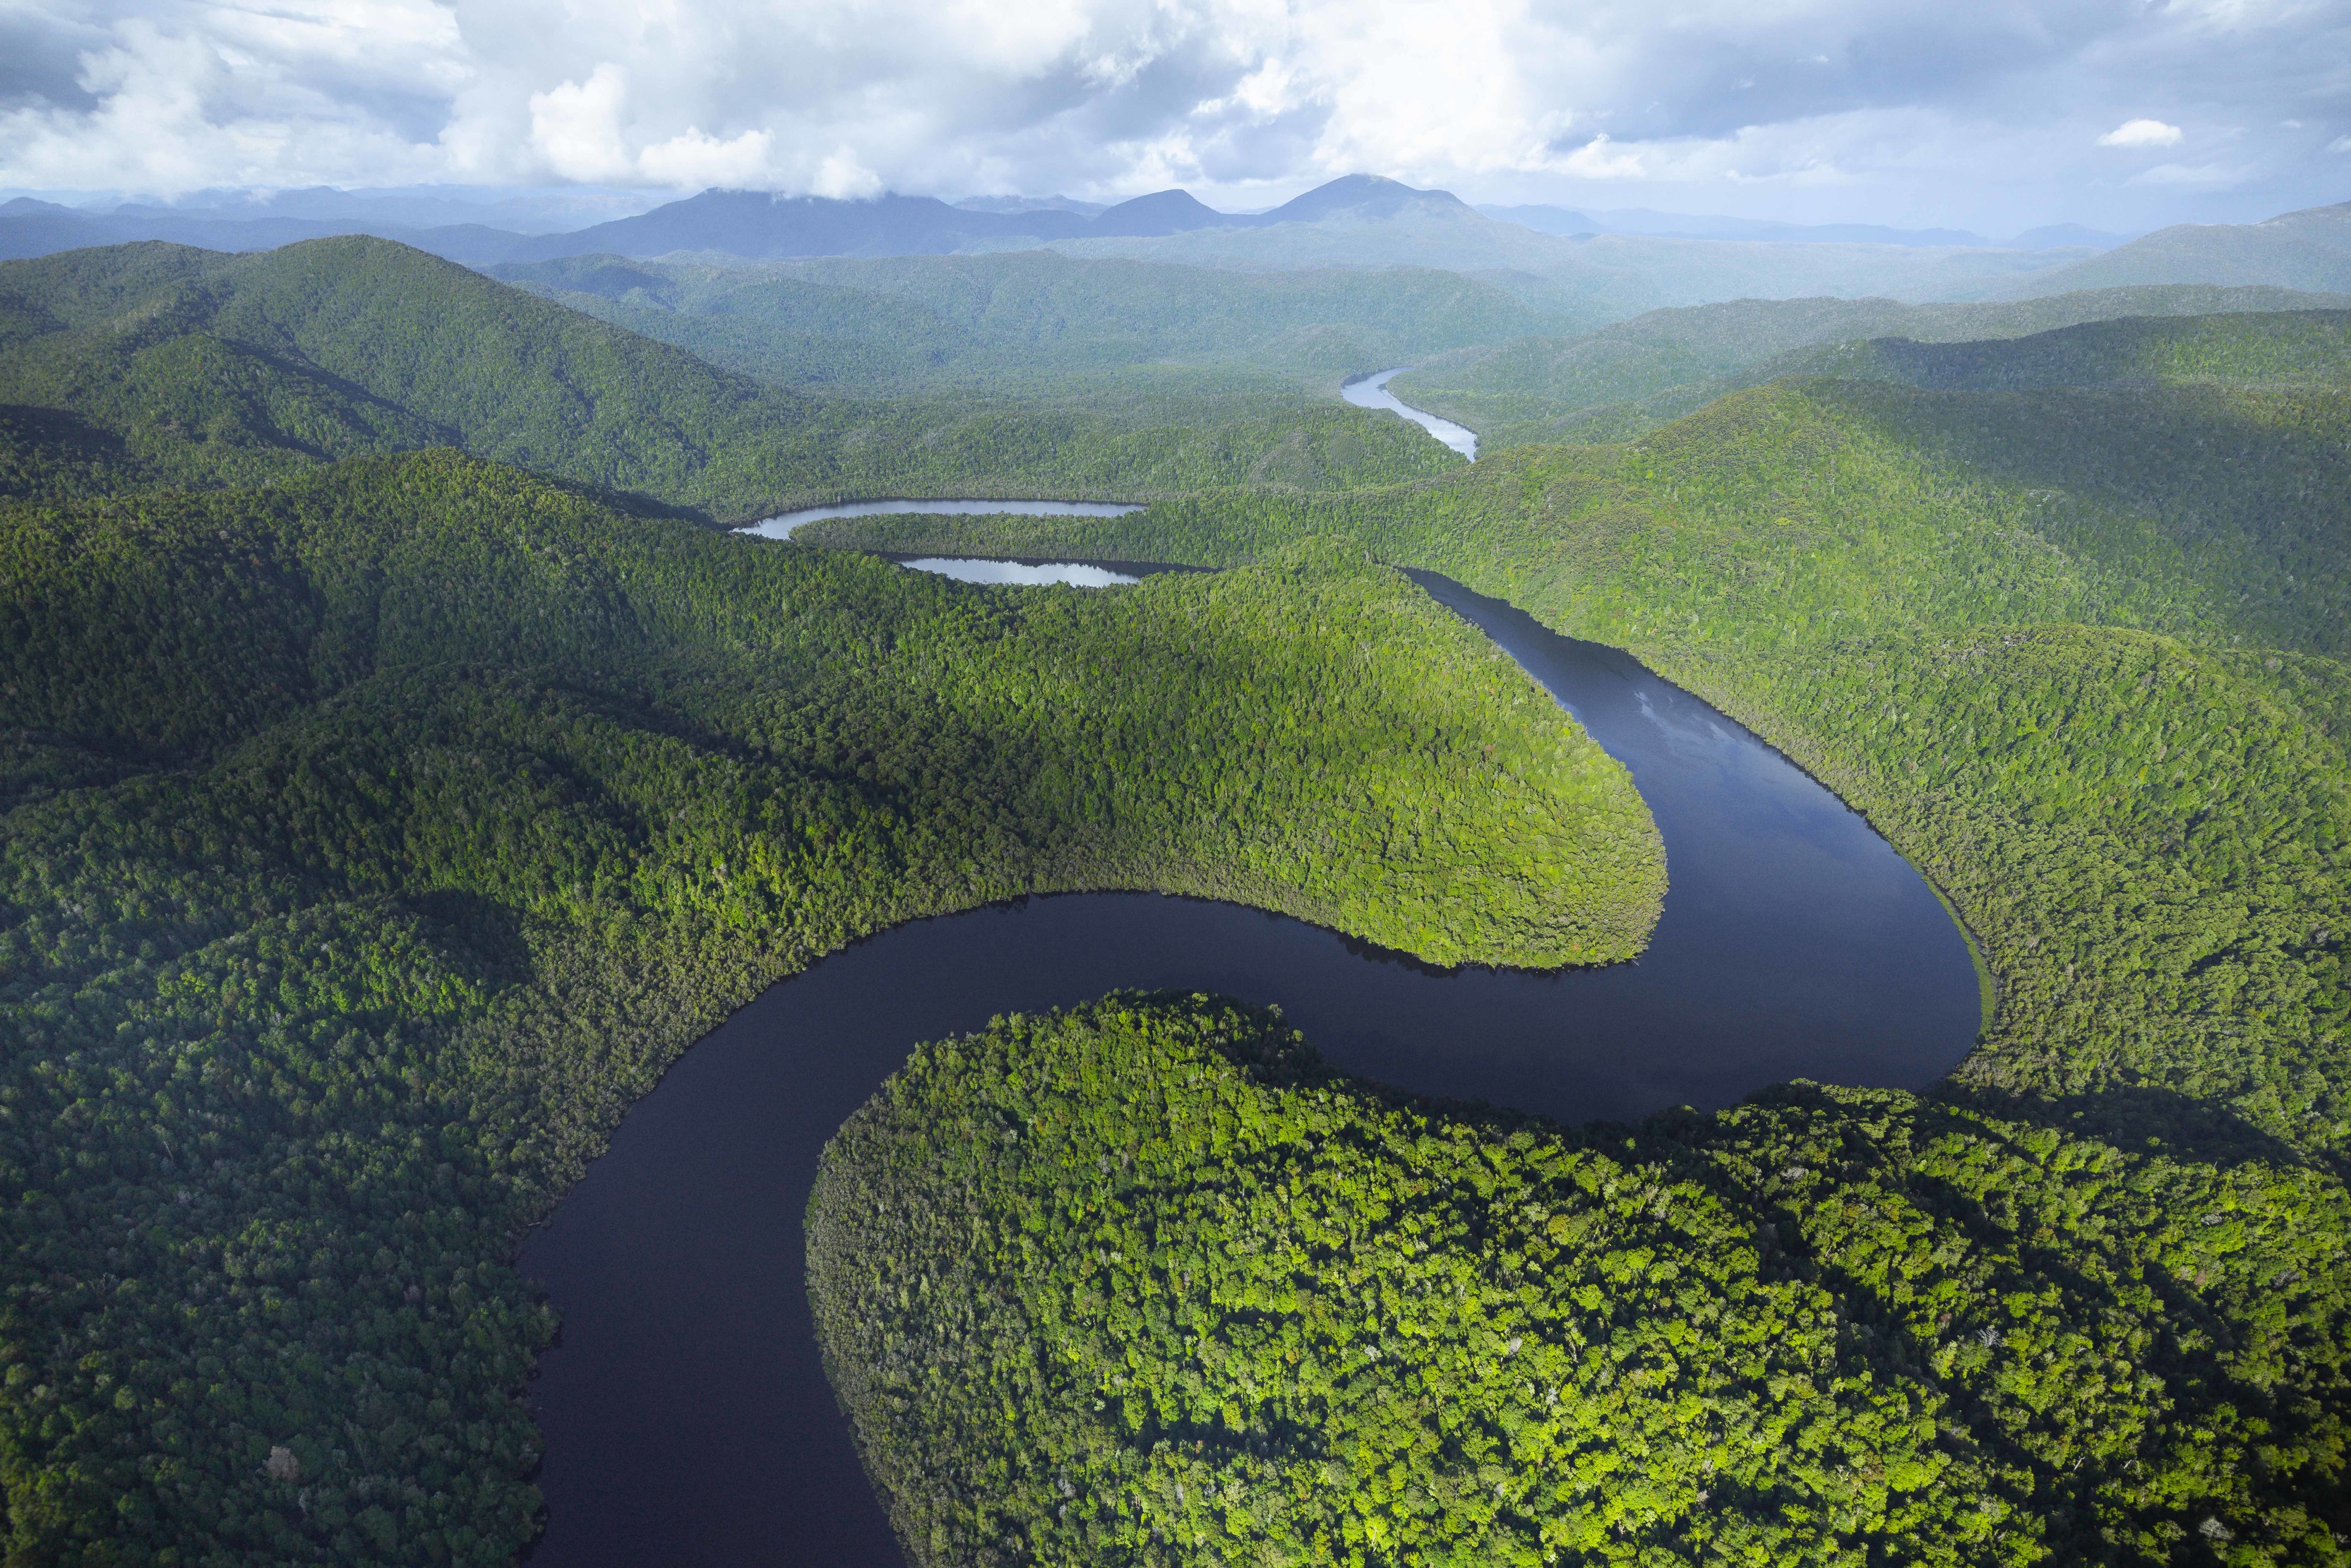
<box><xmin>809</xmin><ymin>995</ymin><xmax>2351</xmax><ymax>1568</ymax></box>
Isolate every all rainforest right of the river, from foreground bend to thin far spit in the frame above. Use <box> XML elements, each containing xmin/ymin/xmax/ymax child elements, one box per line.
<box><xmin>811</xmin><ymin>303</ymin><xmax>2351</xmax><ymax>1563</ymax></box>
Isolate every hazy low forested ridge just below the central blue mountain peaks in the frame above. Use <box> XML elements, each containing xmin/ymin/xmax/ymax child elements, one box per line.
<box><xmin>496</xmin><ymin>251</ymin><xmax>1559</xmax><ymax>397</ymax></box>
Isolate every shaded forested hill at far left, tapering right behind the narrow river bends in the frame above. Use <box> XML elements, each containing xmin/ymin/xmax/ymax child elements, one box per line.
<box><xmin>0</xmin><ymin>237</ymin><xmax>1451</xmax><ymax>522</ymax></box>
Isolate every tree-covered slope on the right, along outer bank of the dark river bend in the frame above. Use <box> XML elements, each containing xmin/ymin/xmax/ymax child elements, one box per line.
<box><xmin>799</xmin><ymin>345</ymin><xmax>2351</xmax><ymax>1159</ymax></box>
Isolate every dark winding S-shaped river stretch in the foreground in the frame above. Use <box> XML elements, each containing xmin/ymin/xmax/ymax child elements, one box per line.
<box><xmin>522</xmin><ymin>576</ymin><xmax>1980</xmax><ymax>1568</ymax></box>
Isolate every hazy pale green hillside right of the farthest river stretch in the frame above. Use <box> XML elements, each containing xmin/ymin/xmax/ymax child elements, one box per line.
<box><xmin>1392</xmin><ymin>285</ymin><xmax>2351</xmax><ymax>451</ymax></box>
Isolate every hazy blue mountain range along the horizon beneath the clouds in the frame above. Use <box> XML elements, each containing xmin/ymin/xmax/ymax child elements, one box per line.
<box><xmin>0</xmin><ymin>174</ymin><xmax>2351</xmax><ymax>327</ymax></box>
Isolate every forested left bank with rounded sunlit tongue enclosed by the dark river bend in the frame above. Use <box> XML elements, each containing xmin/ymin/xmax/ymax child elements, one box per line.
<box><xmin>0</xmin><ymin>451</ymin><xmax>1662</xmax><ymax>1566</ymax></box>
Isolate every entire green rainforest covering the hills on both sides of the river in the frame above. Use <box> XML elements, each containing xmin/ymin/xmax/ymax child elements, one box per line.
<box><xmin>0</xmin><ymin>240</ymin><xmax>2351</xmax><ymax>1566</ymax></box>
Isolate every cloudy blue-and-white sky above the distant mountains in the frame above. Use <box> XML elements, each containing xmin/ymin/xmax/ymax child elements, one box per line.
<box><xmin>0</xmin><ymin>0</ymin><xmax>2351</xmax><ymax>235</ymax></box>
